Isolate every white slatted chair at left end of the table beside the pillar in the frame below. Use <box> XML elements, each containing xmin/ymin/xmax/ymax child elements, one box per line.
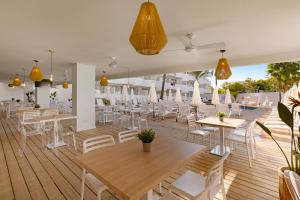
<box><xmin>20</xmin><ymin>111</ymin><xmax>43</xmax><ymax>156</ymax></box>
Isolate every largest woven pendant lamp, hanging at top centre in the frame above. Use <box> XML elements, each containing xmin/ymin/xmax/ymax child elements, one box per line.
<box><xmin>129</xmin><ymin>1</ymin><xmax>168</xmax><ymax>55</ymax></box>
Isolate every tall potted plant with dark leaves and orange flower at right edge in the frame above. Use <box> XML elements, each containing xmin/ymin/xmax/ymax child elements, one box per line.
<box><xmin>256</xmin><ymin>96</ymin><xmax>300</xmax><ymax>200</ymax></box>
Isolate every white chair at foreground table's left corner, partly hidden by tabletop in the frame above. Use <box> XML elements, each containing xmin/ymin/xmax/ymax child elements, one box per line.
<box><xmin>80</xmin><ymin>135</ymin><xmax>115</xmax><ymax>200</ymax></box>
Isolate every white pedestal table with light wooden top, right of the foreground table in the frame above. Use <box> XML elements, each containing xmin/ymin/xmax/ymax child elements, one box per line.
<box><xmin>196</xmin><ymin>117</ymin><xmax>246</xmax><ymax>156</ymax></box>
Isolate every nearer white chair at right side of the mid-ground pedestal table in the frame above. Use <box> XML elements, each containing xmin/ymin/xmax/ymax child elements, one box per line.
<box><xmin>225</xmin><ymin>119</ymin><xmax>256</xmax><ymax>167</ymax></box>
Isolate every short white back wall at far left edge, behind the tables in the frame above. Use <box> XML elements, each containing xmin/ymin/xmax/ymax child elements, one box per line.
<box><xmin>0</xmin><ymin>83</ymin><xmax>24</xmax><ymax>101</ymax></box>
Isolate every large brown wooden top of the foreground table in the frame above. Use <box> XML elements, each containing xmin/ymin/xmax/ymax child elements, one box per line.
<box><xmin>75</xmin><ymin>135</ymin><xmax>205</xmax><ymax>200</ymax></box>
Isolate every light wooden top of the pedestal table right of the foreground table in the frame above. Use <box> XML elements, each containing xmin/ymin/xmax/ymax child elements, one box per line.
<box><xmin>197</xmin><ymin>117</ymin><xmax>246</xmax><ymax>128</ymax></box>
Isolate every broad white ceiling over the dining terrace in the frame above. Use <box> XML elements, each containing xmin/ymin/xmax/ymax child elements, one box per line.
<box><xmin>0</xmin><ymin>0</ymin><xmax>300</xmax><ymax>80</ymax></box>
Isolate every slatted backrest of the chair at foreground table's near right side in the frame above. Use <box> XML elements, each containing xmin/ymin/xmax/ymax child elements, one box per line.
<box><xmin>205</xmin><ymin>152</ymin><xmax>229</xmax><ymax>199</ymax></box>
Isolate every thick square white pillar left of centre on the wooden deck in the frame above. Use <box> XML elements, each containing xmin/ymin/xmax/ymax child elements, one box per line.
<box><xmin>72</xmin><ymin>63</ymin><xmax>96</xmax><ymax>131</ymax></box>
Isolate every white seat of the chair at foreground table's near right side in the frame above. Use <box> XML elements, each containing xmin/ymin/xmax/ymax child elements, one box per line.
<box><xmin>170</xmin><ymin>171</ymin><xmax>206</xmax><ymax>199</ymax></box>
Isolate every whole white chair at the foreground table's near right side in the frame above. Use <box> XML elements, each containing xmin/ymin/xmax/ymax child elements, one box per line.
<box><xmin>161</xmin><ymin>152</ymin><xmax>229</xmax><ymax>200</ymax></box>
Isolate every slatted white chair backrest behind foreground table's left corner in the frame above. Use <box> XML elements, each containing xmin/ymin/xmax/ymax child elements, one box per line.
<box><xmin>83</xmin><ymin>135</ymin><xmax>115</xmax><ymax>153</ymax></box>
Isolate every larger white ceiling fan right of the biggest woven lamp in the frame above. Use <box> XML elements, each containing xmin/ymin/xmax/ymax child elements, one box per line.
<box><xmin>165</xmin><ymin>33</ymin><xmax>225</xmax><ymax>53</ymax></box>
